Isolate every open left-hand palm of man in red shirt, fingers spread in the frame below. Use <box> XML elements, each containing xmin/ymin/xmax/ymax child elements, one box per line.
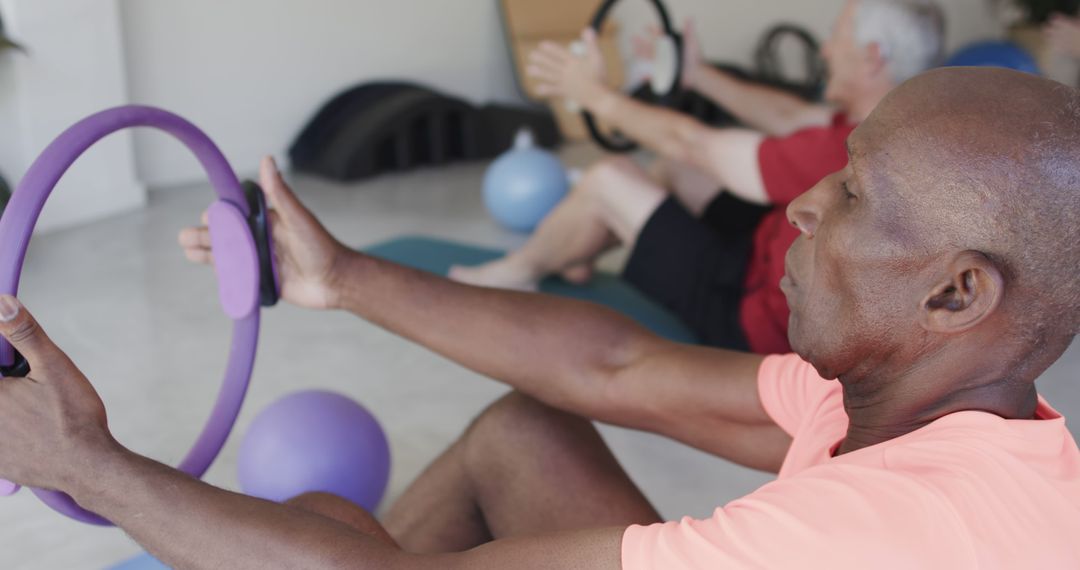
<box><xmin>526</xmin><ymin>28</ymin><xmax>607</xmax><ymax>108</ymax></box>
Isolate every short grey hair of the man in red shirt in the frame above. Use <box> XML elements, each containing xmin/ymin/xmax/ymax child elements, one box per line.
<box><xmin>855</xmin><ymin>0</ymin><xmax>945</xmax><ymax>85</ymax></box>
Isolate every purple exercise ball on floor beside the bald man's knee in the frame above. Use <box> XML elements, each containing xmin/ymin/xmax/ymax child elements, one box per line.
<box><xmin>239</xmin><ymin>390</ymin><xmax>390</xmax><ymax>512</ymax></box>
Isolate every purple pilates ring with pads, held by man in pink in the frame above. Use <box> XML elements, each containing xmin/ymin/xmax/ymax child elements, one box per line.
<box><xmin>0</xmin><ymin>106</ymin><xmax>278</xmax><ymax>526</ymax></box>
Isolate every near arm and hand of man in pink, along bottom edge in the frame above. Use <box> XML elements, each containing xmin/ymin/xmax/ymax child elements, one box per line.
<box><xmin>0</xmin><ymin>296</ymin><xmax>623</xmax><ymax>570</ymax></box>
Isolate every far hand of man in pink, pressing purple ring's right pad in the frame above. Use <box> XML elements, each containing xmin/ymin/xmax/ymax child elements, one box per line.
<box><xmin>179</xmin><ymin>157</ymin><xmax>349</xmax><ymax>309</ymax></box>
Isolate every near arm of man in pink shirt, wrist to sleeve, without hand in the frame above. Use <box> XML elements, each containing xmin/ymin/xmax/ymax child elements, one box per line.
<box><xmin>86</xmin><ymin>449</ymin><xmax>625</xmax><ymax>570</ymax></box>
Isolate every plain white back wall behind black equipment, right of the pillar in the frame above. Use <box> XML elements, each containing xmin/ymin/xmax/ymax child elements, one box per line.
<box><xmin>121</xmin><ymin>0</ymin><xmax>999</xmax><ymax>191</ymax></box>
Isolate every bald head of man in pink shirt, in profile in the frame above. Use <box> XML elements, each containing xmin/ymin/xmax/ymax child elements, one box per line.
<box><xmin>788</xmin><ymin>68</ymin><xmax>1080</xmax><ymax>380</ymax></box>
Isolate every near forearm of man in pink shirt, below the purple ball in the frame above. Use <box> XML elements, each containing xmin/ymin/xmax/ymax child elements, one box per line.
<box><xmin>71</xmin><ymin>446</ymin><xmax>411</xmax><ymax>570</ymax></box>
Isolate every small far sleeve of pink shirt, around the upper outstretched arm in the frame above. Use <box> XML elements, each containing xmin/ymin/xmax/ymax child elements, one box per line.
<box><xmin>757</xmin><ymin>354</ymin><xmax>840</xmax><ymax>437</ymax></box>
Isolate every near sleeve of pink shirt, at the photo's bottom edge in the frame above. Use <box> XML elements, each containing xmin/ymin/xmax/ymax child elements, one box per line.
<box><xmin>622</xmin><ymin>465</ymin><xmax>977</xmax><ymax>570</ymax></box>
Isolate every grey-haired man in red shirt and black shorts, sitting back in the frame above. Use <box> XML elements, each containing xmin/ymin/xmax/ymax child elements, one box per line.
<box><xmin>450</xmin><ymin>0</ymin><xmax>944</xmax><ymax>353</ymax></box>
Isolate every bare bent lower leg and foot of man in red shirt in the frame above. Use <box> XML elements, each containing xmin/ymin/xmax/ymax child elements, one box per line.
<box><xmin>449</xmin><ymin>157</ymin><xmax>667</xmax><ymax>290</ymax></box>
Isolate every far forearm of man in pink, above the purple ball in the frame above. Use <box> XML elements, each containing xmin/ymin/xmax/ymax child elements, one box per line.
<box><xmin>333</xmin><ymin>253</ymin><xmax>654</xmax><ymax>416</ymax></box>
